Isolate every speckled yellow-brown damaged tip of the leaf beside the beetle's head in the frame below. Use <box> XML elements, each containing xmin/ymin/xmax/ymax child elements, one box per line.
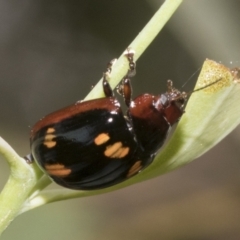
<box><xmin>196</xmin><ymin>59</ymin><xmax>234</xmax><ymax>93</ymax></box>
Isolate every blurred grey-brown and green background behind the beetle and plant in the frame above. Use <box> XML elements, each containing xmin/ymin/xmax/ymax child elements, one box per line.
<box><xmin>0</xmin><ymin>0</ymin><xmax>240</xmax><ymax>240</ymax></box>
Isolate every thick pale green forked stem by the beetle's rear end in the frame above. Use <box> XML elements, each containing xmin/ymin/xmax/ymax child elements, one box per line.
<box><xmin>0</xmin><ymin>138</ymin><xmax>42</xmax><ymax>235</ymax></box>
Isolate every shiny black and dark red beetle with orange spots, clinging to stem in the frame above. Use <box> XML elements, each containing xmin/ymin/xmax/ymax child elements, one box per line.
<box><xmin>30</xmin><ymin>51</ymin><xmax>186</xmax><ymax>190</ymax></box>
